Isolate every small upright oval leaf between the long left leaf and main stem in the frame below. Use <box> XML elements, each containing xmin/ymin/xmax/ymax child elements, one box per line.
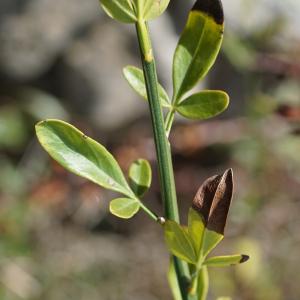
<box><xmin>129</xmin><ymin>159</ymin><xmax>152</xmax><ymax>197</ymax></box>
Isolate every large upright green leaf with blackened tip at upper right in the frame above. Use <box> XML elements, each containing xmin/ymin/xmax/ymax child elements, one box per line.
<box><xmin>173</xmin><ymin>0</ymin><xmax>224</xmax><ymax>102</ymax></box>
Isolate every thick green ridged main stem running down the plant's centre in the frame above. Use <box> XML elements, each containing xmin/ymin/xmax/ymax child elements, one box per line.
<box><xmin>136</xmin><ymin>20</ymin><xmax>189</xmax><ymax>300</ymax></box>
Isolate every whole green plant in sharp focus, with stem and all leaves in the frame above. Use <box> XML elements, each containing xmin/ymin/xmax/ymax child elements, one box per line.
<box><xmin>36</xmin><ymin>0</ymin><xmax>248</xmax><ymax>300</ymax></box>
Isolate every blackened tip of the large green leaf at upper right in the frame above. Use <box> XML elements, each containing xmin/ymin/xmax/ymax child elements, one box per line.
<box><xmin>192</xmin><ymin>0</ymin><xmax>224</xmax><ymax>25</ymax></box>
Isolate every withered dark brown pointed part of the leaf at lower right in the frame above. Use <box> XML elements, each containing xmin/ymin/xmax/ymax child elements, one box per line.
<box><xmin>193</xmin><ymin>169</ymin><xmax>233</xmax><ymax>234</ymax></box>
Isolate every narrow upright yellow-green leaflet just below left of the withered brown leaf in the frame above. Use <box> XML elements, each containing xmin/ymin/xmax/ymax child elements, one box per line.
<box><xmin>188</xmin><ymin>208</ymin><xmax>205</xmax><ymax>256</ymax></box>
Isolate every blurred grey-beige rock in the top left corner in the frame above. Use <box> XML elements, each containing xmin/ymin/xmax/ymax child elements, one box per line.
<box><xmin>0</xmin><ymin>0</ymin><xmax>100</xmax><ymax>80</ymax></box>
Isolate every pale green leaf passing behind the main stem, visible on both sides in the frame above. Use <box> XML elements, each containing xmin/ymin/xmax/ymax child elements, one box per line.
<box><xmin>123</xmin><ymin>66</ymin><xmax>170</xmax><ymax>107</ymax></box>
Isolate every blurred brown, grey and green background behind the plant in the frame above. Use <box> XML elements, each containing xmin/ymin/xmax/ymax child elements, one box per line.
<box><xmin>0</xmin><ymin>0</ymin><xmax>300</xmax><ymax>300</ymax></box>
